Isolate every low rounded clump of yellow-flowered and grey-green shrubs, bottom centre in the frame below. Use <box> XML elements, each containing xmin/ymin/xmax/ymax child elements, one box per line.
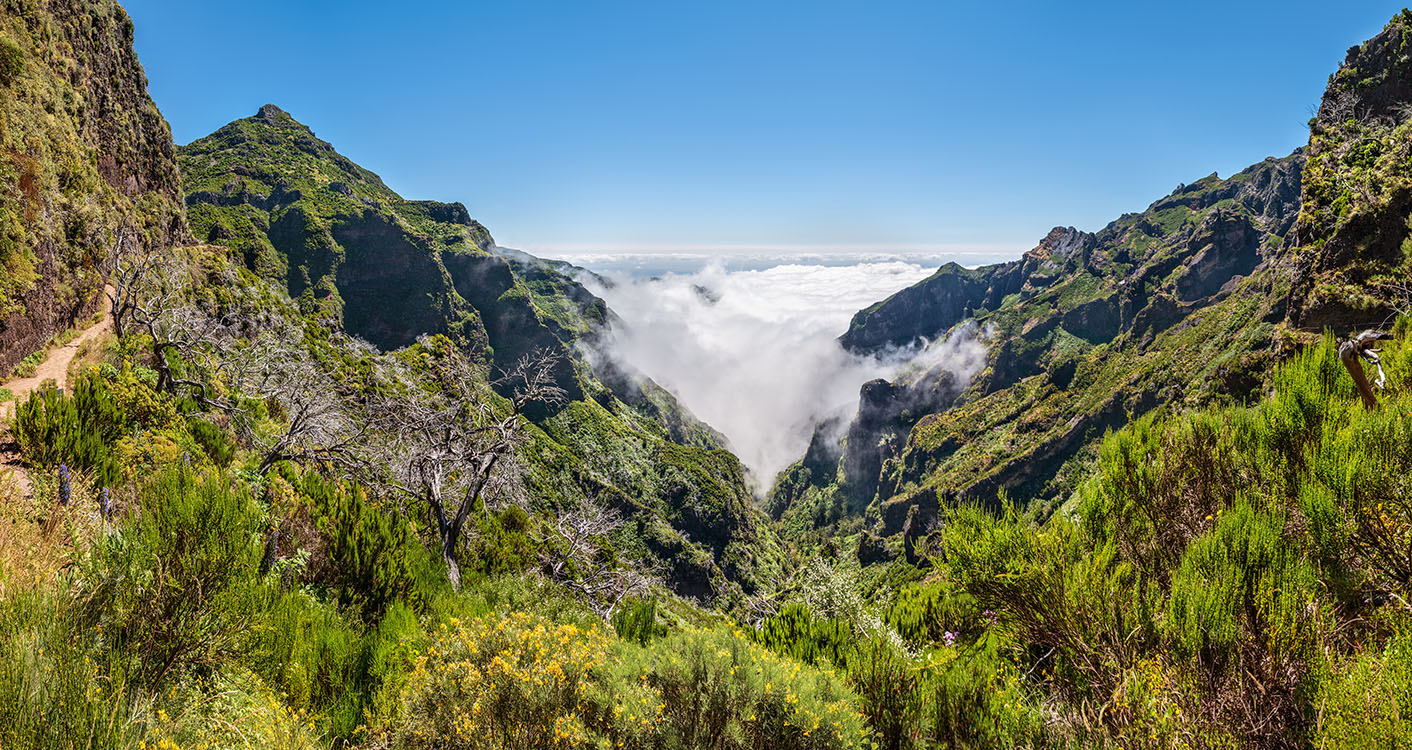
<box><xmin>398</xmin><ymin>613</ymin><xmax>868</xmax><ymax>750</ymax></box>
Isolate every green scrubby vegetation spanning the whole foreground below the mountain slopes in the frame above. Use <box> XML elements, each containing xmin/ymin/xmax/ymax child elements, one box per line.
<box><xmin>0</xmin><ymin>258</ymin><xmax>1412</xmax><ymax>749</ymax></box>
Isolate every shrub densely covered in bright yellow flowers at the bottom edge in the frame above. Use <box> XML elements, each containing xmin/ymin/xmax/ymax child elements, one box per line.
<box><xmin>398</xmin><ymin>612</ymin><xmax>611</xmax><ymax>750</ymax></box>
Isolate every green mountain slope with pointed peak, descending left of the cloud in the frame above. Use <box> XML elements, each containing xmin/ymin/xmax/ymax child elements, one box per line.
<box><xmin>178</xmin><ymin>105</ymin><xmax>782</xmax><ymax>599</ymax></box>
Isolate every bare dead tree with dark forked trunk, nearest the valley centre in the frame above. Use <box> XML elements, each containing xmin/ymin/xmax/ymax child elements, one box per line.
<box><xmin>374</xmin><ymin>350</ymin><xmax>563</xmax><ymax>589</ymax></box>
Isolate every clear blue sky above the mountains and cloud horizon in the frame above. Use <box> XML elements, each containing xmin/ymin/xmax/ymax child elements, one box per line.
<box><xmin>124</xmin><ymin>0</ymin><xmax>1402</xmax><ymax>254</ymax></box>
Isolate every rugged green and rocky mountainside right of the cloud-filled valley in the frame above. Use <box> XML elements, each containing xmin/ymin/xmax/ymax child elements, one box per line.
<box><xmin>777</xmin><ymin>153</ymin><xmax>1303</xmax><ymax>545</ymax></box>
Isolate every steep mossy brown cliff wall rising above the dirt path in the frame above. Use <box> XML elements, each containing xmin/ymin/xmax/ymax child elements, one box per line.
<box><xmin>0</xmin><ymin>0</ymin><xmax>186</xmax><ymax>371</ymax></box>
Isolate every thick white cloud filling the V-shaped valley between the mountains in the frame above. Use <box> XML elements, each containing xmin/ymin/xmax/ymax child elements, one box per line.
<box><xmin>583</xmin><ymin>261</ymin><xmax>984</xmax><ymax>486</ymax></box>
